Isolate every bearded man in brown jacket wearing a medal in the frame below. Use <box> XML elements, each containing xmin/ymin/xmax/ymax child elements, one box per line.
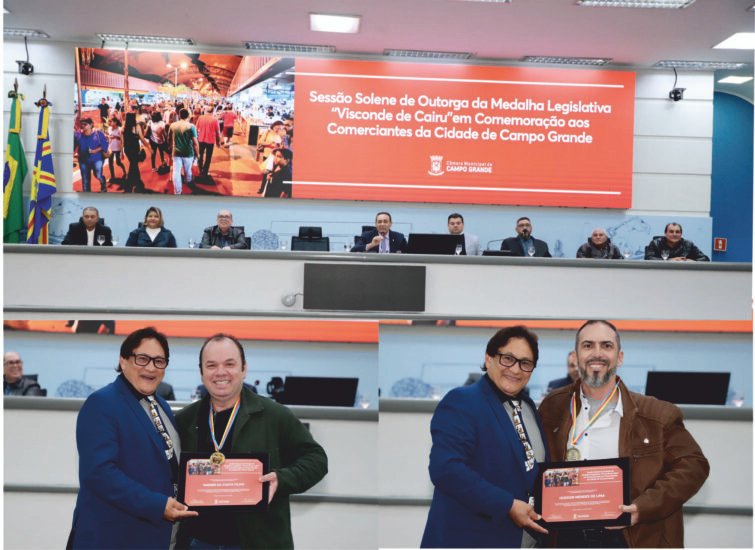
<box><xmin>540</xmin><ymin>321</ymin><xmax>710</xmax><ymax>548</ymax></box>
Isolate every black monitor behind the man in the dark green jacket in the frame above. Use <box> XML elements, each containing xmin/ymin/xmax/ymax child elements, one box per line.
<box><xmin>278</xmin><ymin>376</ymin><xmax>359</xmax><ymax>407</ymax></box>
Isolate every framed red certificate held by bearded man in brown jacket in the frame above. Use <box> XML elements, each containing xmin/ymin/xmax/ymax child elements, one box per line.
<box><xmin>535</xmin><ymin>457</ymin><xmax>631</xmax><ymax>529</ymax></box>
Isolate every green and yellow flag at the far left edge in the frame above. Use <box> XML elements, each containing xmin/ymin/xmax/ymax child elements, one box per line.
<box><xmin>3</xmin><ymin>92</ymin><xmax>28</xmax><ymax>243</ymax></box>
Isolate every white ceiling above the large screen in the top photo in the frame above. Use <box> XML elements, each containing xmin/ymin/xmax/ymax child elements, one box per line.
<box><xmin>4</xmin><ymin>0</ymin><xmax>755</xmax><ymax>100</ymax></box>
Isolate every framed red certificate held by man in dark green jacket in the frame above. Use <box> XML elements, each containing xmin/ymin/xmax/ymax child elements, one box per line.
<box><xmin>178</xmin><ymin>452</ymin><xmax>270</xmax><ymax>512</ymax></box>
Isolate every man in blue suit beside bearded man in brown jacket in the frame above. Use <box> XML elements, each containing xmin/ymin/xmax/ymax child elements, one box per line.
<box><xmin>422</xmin><ymin>326</ymin><xmax>548</xmax><ymax>548</ymax></box>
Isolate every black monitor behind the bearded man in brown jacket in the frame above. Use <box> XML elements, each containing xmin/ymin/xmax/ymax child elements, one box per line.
<box><xmin>645</xmin><ymin>371</ymin><xmax>731</xmax><ymax>405</ymax></box>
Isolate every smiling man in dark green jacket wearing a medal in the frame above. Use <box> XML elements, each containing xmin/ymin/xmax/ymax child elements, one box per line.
<box><xmin>176</xmin><ymin>334</ymin><xmax>328</xmax><ymax>548</ymax></box>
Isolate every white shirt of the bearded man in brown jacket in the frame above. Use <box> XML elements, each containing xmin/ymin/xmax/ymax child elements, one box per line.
<box><xmin>566</xmin><ymin>391</ymin><xmax>624</xmax><ymax>460</ymax></box>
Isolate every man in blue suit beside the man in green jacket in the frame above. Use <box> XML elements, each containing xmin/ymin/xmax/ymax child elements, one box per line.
<box><xmin>68</xmin><ymin>327</ymin><xmax>197</xmax><ymax>550</ymax></box>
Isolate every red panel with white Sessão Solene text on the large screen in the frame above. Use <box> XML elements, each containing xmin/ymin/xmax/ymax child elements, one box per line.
<box><xmin>293</xmin><ymin>58</ymin><xmax>635</xmax><ymax>208</ymax></box>
